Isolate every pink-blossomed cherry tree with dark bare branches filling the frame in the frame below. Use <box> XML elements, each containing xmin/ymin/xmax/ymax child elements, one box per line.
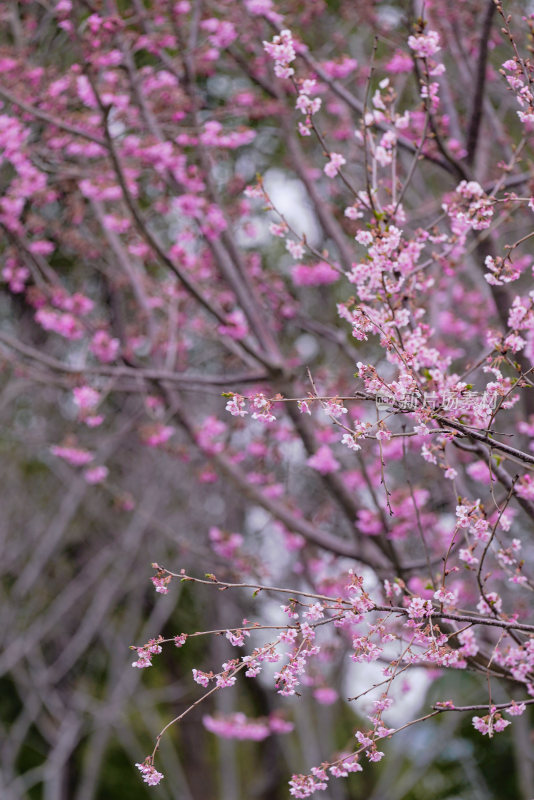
<box><xmin>0</xmin><ymin>0</ymin><xmax>534</xmax><ymax>800</ymax></box>
